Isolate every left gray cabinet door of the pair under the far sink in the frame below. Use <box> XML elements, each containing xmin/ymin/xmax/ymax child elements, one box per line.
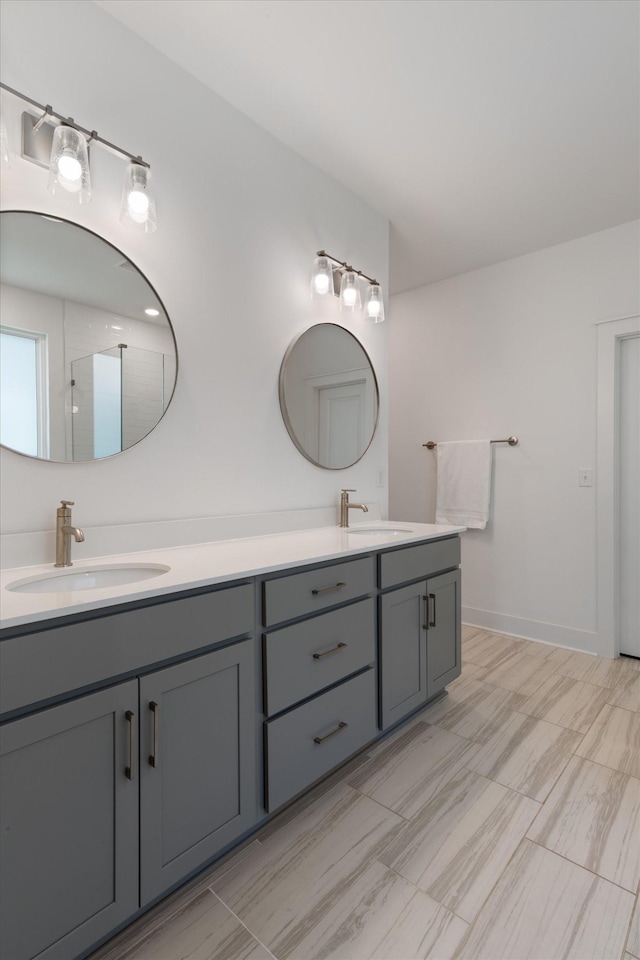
<box><xmin>380</xmin><ymin>581</ymin><xmax>427</xmax><ymax>730</ymax></box>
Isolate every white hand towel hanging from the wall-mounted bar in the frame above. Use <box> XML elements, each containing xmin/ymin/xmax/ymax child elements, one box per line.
<box><xmin>436</xmin><ymin>440</ymin><xmax>491</xmax><ymax>530</ymax></box>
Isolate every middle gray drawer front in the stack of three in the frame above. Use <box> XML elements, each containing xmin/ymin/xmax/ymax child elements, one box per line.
<box><xmin>263</xmin><ymin>598</ymin><xmax>376</xmax><ymax>715</ymax></box>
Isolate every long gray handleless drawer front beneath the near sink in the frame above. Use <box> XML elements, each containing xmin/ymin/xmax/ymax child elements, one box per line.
<box><xmin>0</xmin><ymin>583</ymin><xmax>253</xmax><ymax>713</ymax></box>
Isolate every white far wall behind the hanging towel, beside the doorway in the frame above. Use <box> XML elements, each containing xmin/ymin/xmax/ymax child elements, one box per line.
<box><xmin>389</xmin><ymin>222</ymin><xmax>640</xmax><ymax>652</ymax></box>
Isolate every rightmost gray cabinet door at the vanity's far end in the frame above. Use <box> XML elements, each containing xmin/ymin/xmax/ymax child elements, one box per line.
<box><xmin>427</xmin><ymin>570</ymin><xmax>462</xmax><ymax>697</ymax></box>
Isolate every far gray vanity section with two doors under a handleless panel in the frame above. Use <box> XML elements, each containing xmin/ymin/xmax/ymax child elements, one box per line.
<box><xmin>379</xmin><ymin>537</ymin><xmax>461</xmax><ymax>730</ymax></box>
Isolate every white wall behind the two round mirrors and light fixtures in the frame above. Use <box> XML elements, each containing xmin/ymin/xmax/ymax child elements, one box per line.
<box><xmin>1</xmin><ymin>0</ymin><xmax>388</xmax><ymax>540</ymax></box>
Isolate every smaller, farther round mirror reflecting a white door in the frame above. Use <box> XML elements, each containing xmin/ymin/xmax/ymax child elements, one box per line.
<box><xmin>279</xmin><ymin>323</ymin><xmax>379</xmax><ymax>470</ymax></box>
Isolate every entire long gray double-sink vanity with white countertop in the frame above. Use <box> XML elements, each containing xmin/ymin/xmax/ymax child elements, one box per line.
<box><xmin>0</xmin><ymin>524</ymin><xmax>461</xmax><ymax>960</ymax></box>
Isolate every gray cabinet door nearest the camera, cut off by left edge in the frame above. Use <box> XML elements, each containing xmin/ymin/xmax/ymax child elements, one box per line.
<box><xmin>0</xmin><ymin>680</ymin><xmax>138</xmax><ymax>960</ymax></box>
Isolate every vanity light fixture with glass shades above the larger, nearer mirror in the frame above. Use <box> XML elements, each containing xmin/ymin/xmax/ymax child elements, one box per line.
<box><xmin>0</xmin><ymin>82</ymin><xmax>156</xmax><ymax>233</ymax></box>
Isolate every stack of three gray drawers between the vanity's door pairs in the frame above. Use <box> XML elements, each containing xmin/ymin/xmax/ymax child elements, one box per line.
<box><xmin>262</xmin><ymin>556</ymin><xmax>378</xmax><ymax>813</ymax></box>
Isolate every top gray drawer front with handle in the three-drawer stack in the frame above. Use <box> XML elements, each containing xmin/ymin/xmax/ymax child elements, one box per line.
<box><xmin>262</xmin><ymin>557</ymin><xmax>374</xmax><ymax>627</ymax></box>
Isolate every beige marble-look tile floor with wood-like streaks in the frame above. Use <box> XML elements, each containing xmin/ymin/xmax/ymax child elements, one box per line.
<box><xmin>91</xmin><ymin>627</ymin><xmax>640</xmax><ymax>960</ymax></box>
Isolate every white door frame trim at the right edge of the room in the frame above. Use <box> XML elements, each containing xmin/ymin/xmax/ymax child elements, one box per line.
<box><xmin>596</xmin><ymin>316</ymin><xmax>640</xmax><ymax>658</ymax></box>
